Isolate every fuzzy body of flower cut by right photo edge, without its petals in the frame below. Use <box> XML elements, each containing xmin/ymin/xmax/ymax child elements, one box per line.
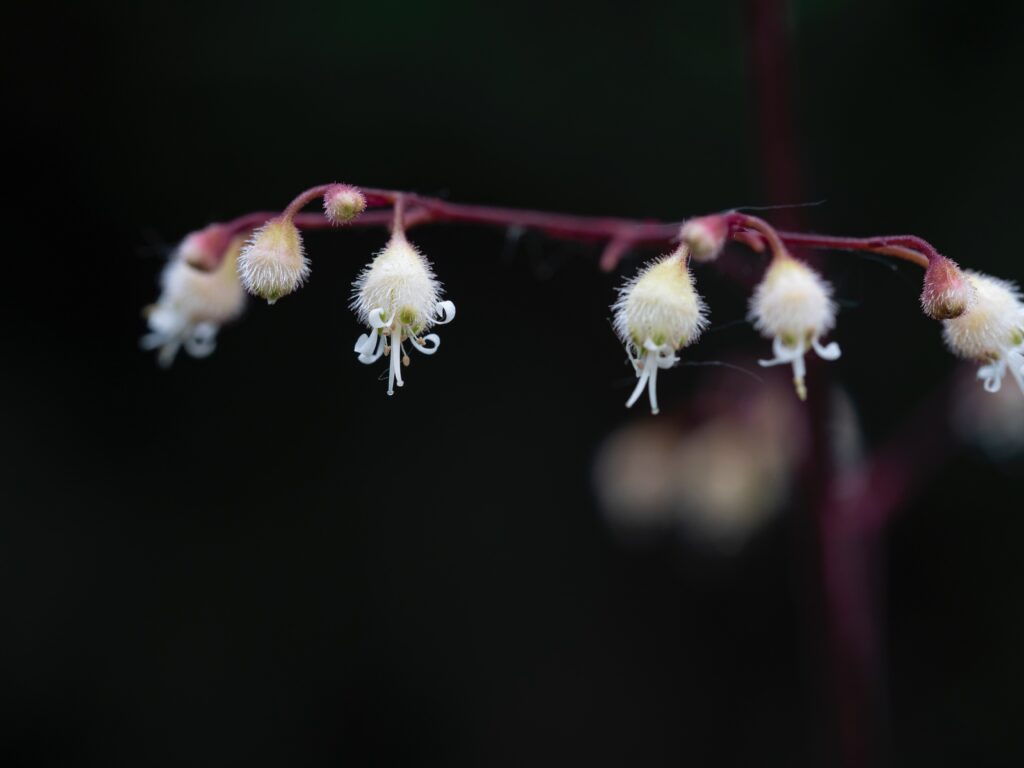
<box><xmin>942</xmin><ymin>270</ymin><xmax>1024</xmax><ymax>362</ymax></box>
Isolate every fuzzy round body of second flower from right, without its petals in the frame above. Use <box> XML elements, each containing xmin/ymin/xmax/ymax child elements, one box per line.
<box><xmin>749</xmin><ymin>256</ymin><xmax>838</xmax><ymax>345</ymax></box>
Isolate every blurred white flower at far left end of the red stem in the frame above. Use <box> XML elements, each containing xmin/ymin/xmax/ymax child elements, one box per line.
<box><xmin>139</xmin><ymin>239</ymin><xmax>246</xmax><ymax>368</ymax></box>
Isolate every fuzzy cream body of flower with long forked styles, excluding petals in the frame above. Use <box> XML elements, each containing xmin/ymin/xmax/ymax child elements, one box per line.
<box><xmin>612</xmin><ymin>249</ymin><xmax>708</xmax><ymax>349</ymax></box>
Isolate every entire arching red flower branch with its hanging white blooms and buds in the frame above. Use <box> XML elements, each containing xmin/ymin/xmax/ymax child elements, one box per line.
<box><xmin>141</xmin><ymin>189</ymin><xmax>1024</xmax><ymax>414</ymax></box>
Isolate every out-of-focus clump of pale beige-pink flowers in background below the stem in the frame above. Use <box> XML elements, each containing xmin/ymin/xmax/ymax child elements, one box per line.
<box><xmin>594</xmin><ymin>378</ymin><xmax>806</xmax><ymax>551</ymax></box>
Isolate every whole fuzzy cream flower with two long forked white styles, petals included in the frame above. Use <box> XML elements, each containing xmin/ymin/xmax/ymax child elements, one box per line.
<box><xmin>611</xmin><ymin>249</ymin><xmax>708</xmax><ymax>414</ymax></box>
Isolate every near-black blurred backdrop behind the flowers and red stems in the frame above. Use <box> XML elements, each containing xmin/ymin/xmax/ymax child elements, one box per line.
<box><xmin>6</xmin><ymin>0</ymin><xmax>1024</xmax><ymax>767</ymax></box>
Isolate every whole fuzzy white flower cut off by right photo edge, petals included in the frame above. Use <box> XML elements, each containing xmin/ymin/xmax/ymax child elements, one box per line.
<box><xmin>942</xmin><ymin>270</ymin><xmax>1024</xmax><ymax>392</ymax></box>
